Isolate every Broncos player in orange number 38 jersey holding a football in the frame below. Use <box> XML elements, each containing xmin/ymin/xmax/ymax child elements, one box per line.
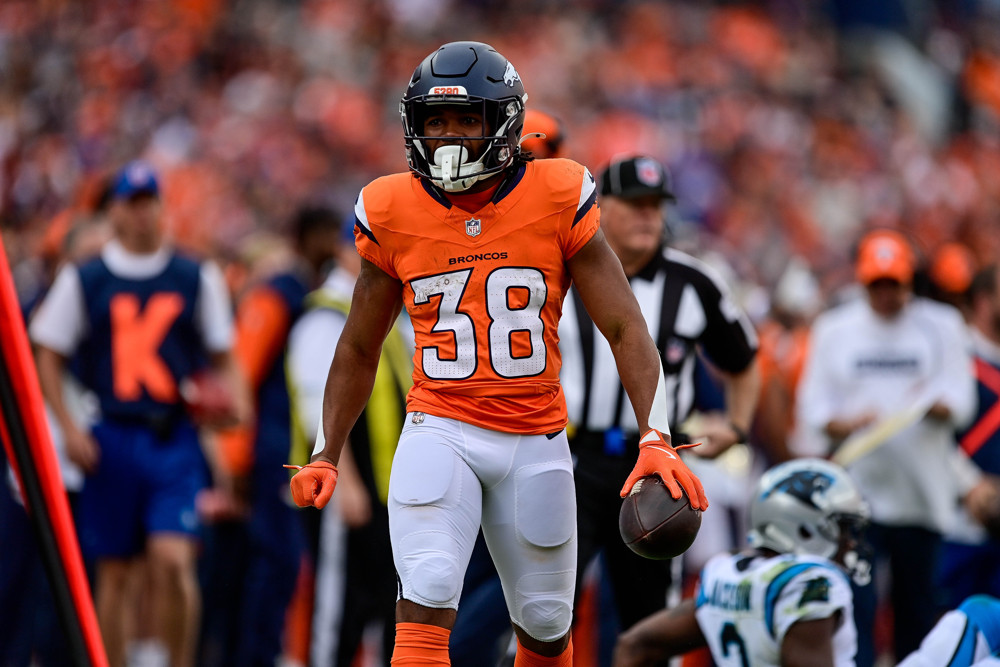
<box><xmin>291</xmin><ymin>42</ymin><xmax>708</xmax><ymax>666</ymax></box>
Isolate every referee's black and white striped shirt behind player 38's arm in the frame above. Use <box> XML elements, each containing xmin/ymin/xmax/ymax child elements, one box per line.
<box><xmin>559</xmin><ymin>248</ymin><xmax>757</xmax><ymax>436</ymax></box>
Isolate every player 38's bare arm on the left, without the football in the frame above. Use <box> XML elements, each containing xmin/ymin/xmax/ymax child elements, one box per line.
<box><xmin>312</xmin><ymin>259</ymin><xmax>402</xmax><ymax>465</ymax></box>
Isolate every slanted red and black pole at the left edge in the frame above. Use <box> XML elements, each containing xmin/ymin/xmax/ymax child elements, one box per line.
<box><xmin>0</xmin><ymin>235</ymin><xmax>108</xmax><ymax>667</ymax></box>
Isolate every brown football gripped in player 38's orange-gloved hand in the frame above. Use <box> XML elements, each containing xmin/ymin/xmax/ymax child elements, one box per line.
<box><xmin>618</xmin><ymin>475</ymin><xmax>701</xmax><ymax>560</ymax></box>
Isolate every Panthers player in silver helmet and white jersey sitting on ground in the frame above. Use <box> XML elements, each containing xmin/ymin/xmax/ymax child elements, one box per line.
<box><xmin>614</xmin><ymin>459</ymin><xmax>870</xmax><ymax>667</ymax></box>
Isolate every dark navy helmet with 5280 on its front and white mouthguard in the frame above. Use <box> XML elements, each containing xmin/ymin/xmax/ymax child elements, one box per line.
<box><xmin>399</xmin><ymin>42</ymin><xmax>528</xmax><ymax>192</ymax></box>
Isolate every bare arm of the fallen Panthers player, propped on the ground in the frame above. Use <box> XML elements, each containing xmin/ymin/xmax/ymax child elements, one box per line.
<box><xmin>614</xmin><ymin>600</ymin><xmax>707</xmax><ymax>667</ymax></box>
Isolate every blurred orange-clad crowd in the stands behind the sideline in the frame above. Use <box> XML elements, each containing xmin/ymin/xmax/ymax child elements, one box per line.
<box><xmin>0</xmin><ymin>0</ymin><xmax>1000</xmax><ymax>664</ymax></box>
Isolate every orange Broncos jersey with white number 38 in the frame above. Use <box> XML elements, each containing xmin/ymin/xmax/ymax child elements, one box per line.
<box><xmin>354</xmin><ymin>160</ymin><xmax>600</xmax><ymax>434</ymax></box>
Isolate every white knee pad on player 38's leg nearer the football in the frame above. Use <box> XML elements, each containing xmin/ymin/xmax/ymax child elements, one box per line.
<box><xmin>512</xmin><ymin>571</ymin><xmax>575</xmax><ymax>642</ymax></box>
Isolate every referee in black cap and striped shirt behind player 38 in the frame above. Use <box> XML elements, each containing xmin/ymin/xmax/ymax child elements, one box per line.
<box><xmin>559</xmin><ymin>156</ymin><xmax>760</xmax><ymax>630</ymax></box>
